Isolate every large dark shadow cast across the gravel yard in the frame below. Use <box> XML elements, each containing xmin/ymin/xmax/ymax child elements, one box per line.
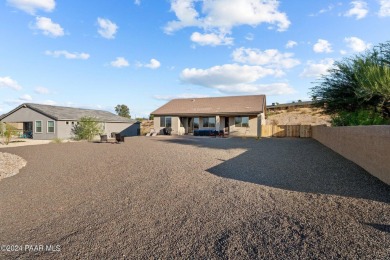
<box><xmin>159</xmin><ymin>137</ymin><xmax>390</xmax><ymax>203</ymax></box>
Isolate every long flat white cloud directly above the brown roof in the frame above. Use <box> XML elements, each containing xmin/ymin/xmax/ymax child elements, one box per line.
<box><xmin>180</xmin><ymin>64</ymin><xmax>294</xmax><ymax>95</ymax></box>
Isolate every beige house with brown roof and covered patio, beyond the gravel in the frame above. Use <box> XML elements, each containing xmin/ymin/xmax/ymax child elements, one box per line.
<box><xmin>151</xmin><ymin>95</ymin><xmax>266</xmax><ymax>137</ymax></box>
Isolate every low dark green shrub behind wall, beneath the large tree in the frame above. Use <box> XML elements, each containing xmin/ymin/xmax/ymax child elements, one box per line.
<box><xmin>331</xmin><ymin>109</ymin><xmax>390</xmax><ymax>126</ymax></box>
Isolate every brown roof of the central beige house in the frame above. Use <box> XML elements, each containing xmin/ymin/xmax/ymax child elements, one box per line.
<box><xmin>151</xmin><ymin>95</ymin><xmax>266</xmax><ymax>116</ymax></box>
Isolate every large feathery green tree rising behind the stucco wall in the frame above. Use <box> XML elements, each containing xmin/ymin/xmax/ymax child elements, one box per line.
<box><xmin>311</xmin><ymin>42</ymin><xmax>390</xmax><ymax>123</ymax></box>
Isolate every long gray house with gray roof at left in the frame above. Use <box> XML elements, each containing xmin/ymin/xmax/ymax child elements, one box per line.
<box><xmin>0</xmin><ymin>103</ymin><xmax>140</xmax><ymax>140</ymax></box>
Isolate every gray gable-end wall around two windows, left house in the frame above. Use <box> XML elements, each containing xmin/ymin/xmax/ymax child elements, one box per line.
<box><xmin>1</xmin><ymin>107</ymin><xmax>58</xmax><ymax>140</ymax></box>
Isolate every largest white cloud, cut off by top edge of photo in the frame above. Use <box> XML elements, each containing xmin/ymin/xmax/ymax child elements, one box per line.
<box><xmin>164</xmin><ymin>0</ymin><xmax>290</xmax><ymax>33</ymax></box>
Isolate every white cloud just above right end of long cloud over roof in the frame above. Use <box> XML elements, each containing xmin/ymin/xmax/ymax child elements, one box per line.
<box><xmin>232</xmin><ymin>48</ymin><xmax>300</xmax><ymax>69</ymax></box>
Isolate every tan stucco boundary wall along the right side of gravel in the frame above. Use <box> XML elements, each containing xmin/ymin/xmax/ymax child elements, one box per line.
<box><xmin>312</xmin><ymin>126</ymin><xmax>390</xmax><ymax>185</ymax></box>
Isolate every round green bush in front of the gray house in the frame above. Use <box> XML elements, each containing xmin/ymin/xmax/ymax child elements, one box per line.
<box><xmin>72</xmin><ymin>116</ymin><xmax>103</xmax><ymax>141</ymax></box>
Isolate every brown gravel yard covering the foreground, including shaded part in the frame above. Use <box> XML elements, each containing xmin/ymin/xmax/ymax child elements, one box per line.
<box><xmin>0</xmin><ymin>137</ymin><xmax>390</xmax><ymax>259</ymax></box>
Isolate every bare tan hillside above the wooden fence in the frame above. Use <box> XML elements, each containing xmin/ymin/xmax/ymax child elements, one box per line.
<box><xmin>267</xmin><ymin>107</ymin><xmax>330</xmax><ymax>126</ymax></box>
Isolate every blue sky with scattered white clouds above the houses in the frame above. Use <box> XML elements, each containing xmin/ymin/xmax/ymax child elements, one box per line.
<box><xmin>0</xmin><ymin>0</ymin><xmax>390</xmax><ymax>117</ymax></box>
